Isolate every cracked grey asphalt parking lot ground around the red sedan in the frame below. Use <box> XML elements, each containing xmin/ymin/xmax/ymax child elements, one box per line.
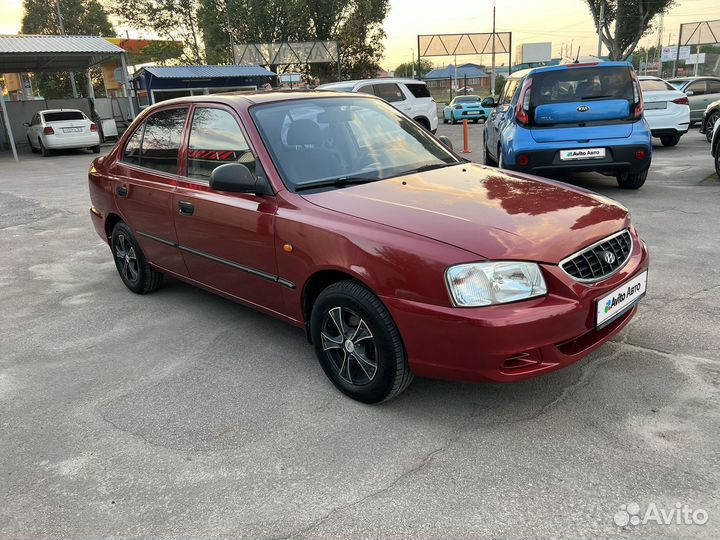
<box><xmin>0</xmin><ymin>132</ymin><xmax>720</xmax><ymax>539</ymax></box>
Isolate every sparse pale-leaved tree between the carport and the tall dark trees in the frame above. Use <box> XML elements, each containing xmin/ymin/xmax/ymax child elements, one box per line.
<box><xmin>112</xmin><ymin>0</ymin><xmax>205</xmax><ymax>64</ymax></box>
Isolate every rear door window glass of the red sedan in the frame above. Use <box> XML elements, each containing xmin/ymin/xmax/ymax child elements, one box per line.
<box><xmin>140</xmin><ymin>109</ymin><xmax>187</xmax><ymax>174</ymax></box>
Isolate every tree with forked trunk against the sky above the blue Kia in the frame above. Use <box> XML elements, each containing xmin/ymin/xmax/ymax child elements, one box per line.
<box><xmin>586</xmin><ymin>0</ymin><xmax>676</xmax><ymax>60</ymax></box>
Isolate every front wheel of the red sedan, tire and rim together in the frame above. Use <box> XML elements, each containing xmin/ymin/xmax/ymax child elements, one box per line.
<box><xmin>310</xmin><ymin>280</ymin><xmax>413</xmax><ymax>403</ymax></box>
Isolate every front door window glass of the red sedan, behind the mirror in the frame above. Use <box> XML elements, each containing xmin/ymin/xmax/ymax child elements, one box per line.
<box><xmin>187</xmin><ymin>108</ymin><xmax>255</xmax><ymax>182</ymax></box>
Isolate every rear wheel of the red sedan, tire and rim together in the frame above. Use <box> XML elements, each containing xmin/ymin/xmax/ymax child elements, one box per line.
<box><xmin>110</xmin><ymin>221</ymin><xmax>163</xmax><ymax>294</ymax></box>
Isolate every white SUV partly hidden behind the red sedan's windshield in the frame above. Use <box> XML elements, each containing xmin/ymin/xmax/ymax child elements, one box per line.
<box><xmin>316</xmin><ymin>79</ymin><xmax>438</xmax><ymax>133</ymax></box>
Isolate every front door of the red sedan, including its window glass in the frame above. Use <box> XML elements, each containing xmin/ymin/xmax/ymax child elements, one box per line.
<box><xmin>173</xmin><ymin>104</ymin><xmax>283</xmax><ymax>312</ymax></box>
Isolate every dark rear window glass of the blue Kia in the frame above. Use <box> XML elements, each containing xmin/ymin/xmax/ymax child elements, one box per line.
<box><xmin>530</xmin><ymin>67</ymin><xmax>633</xmax><ymax>106</ymax></box>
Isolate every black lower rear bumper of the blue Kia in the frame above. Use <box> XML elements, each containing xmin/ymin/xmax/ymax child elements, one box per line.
<box><xmin>503</xmin><ymin>141</ymin><xmax>652</xmax><ymax>176</ymax></box>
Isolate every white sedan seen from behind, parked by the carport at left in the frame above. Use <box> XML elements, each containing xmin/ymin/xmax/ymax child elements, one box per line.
<box><xmin>25</xmin><ymin>109</ymin><xmax>100</xmax><ymax>156</ymax></box>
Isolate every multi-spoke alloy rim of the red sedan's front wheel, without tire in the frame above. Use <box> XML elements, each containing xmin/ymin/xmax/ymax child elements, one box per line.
<box><xmin>320</xmin><ymin>307</ymin><xmax>378</xmax><ymax>386</ymax></box>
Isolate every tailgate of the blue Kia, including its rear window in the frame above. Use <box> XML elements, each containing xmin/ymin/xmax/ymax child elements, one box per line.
<box><xmin>530</xmin><ymin>65</ymin><xmax>634</xmax><ymax>143</ymax></box>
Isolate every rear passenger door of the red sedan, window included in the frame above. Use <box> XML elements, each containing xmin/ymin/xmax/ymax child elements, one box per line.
<box><xmin>112</xmin><ymin>107</ymin><xmax>188</xmax><ymax>276</ymax></box>
